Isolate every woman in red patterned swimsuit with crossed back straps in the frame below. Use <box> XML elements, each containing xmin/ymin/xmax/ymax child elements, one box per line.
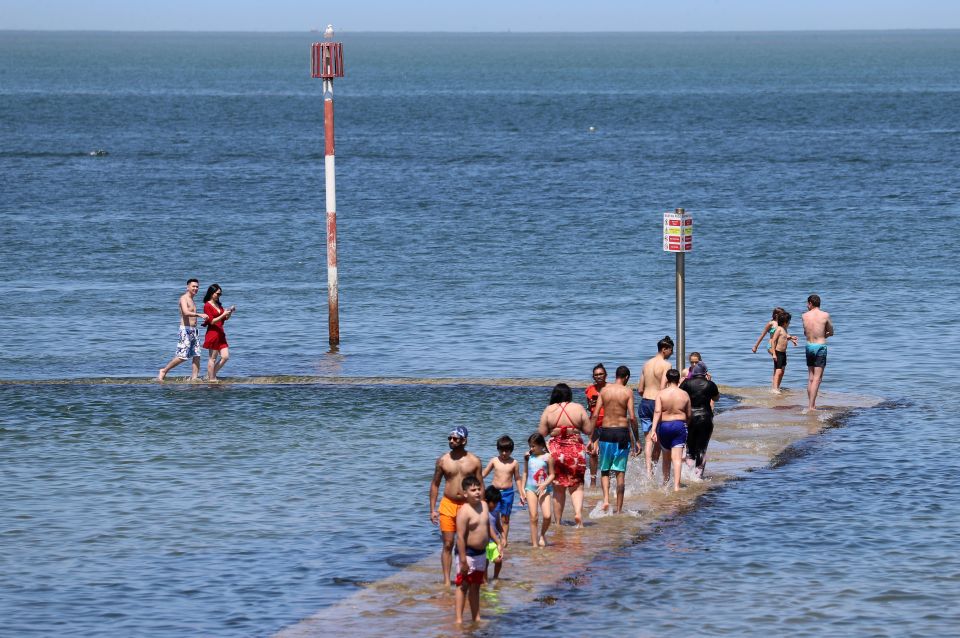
<box><xmin>537</xmin><ymin>383</ymin><xmax>593</xmax><ymax>527</ymax></box>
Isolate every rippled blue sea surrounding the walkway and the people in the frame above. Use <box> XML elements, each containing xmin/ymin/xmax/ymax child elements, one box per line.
<box><xmin>0</xmin><ymin>30</ymin><xmax>960</xmax><ymax>637</ymax></box>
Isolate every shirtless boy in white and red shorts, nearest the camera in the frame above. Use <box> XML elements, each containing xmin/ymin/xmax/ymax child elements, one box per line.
<box><xmin>456</xmin><ymin>480</ymin><xmax>490</xmax><ymax>625</ymax></box>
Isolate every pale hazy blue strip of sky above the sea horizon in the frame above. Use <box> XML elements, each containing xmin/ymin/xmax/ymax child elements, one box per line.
<box><xmin>0</xmin><ymin>0</ymin><xmax>960</xmax><ymax>32</ymax></box>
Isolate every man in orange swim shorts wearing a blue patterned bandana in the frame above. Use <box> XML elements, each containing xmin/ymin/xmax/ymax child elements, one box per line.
<box><xmin>430</xmin><ymin>425</ymin><xmax>483</xmax><ymax>585</ymax></box>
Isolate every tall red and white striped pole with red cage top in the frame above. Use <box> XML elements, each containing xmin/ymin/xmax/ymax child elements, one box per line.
<box><xmin>311</xmin><ymin>24</ymin><xmax>343</xmax><ymax>347</ymax></box>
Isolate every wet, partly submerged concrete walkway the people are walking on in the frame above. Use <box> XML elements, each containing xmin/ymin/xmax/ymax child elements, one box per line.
<box><xmin>276</xmin><ymin>379</ymin><xmax>879</xmax><ymax>638</ymax></box>
